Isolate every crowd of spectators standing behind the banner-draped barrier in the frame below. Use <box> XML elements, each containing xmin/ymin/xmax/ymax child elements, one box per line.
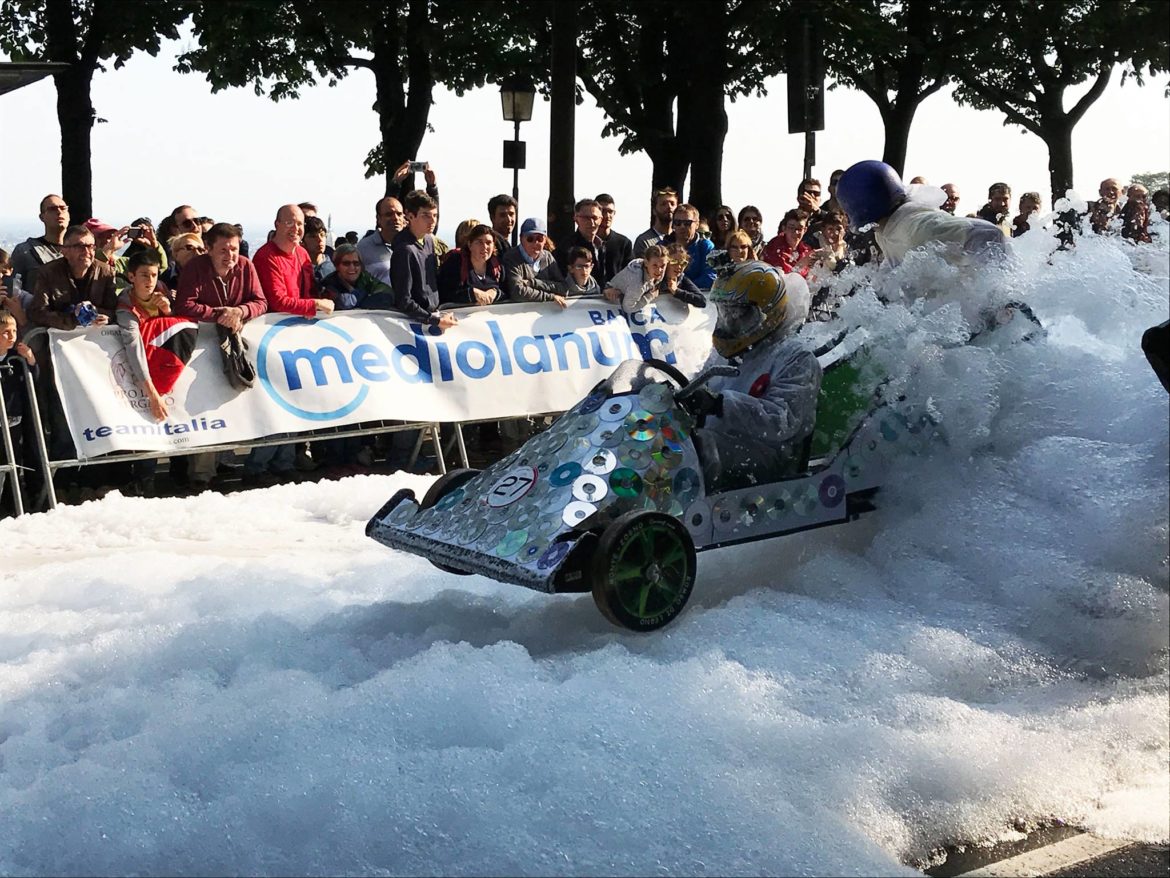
<box><xmin>0</xmin><ymin>156</ymin><xmax>1170</xmax><ymax>509</ymax></box>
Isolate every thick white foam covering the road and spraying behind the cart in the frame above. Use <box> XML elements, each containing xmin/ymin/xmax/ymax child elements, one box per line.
<box><xmin>0</xmin><ymin>229</ymin><xmax>1170</xmax><ymax>874</ymax></box>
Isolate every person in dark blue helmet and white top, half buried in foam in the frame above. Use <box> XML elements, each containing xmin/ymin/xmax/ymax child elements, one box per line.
<box><xmin>837</xmin><ymin>160</ymin><xmax>1011</xmax><ymax>266</ymax></box>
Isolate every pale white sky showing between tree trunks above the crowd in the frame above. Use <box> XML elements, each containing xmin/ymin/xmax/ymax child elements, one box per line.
<box><xmin>0</xmin><ymin>33</ymin><xmax>1170</xmax><ymax>243</ymax></box>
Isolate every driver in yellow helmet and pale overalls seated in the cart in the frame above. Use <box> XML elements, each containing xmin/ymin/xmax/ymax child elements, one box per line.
<box><xmin>689</xmin><ymin>262</ymin><xmax>821</xmax><ymax>491</ymax></box>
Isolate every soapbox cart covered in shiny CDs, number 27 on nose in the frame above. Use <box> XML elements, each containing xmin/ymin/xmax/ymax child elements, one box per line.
<box><xmin>366</xmin><ymin>346</ymin><xmax>938</xmax><ymax>631</ymax></box>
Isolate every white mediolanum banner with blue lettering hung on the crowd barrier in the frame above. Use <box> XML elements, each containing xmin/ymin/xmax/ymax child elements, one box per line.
<box><xmin>49</xmin><ymin>299</ymin><xmax>715</xmax><ymax>459</ymax></box>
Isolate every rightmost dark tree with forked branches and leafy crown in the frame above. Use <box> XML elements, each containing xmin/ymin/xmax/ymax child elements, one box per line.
<box><xmin>955</xmin><ymin>0</ymin><xmax>1170</xmax><ymax>199</ymax></box>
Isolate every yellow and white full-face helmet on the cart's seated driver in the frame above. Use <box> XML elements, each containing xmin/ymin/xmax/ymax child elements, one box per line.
<box><xmin>707</xmin><ymin>262</ymin><xmax>789</xmax><ymax>357</ymax></box>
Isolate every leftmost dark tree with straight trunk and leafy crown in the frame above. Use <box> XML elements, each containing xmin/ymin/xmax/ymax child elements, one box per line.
<box><xmin>0</xmin><ymin>0</ymin><xmax>188</xmax><ymax>219</ymax></box>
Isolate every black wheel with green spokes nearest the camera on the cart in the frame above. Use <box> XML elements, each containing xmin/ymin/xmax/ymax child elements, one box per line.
<box><xmin>592</xmin><ymin>509</ymin><xmax>695</xmax><ymax>631</ymax></box>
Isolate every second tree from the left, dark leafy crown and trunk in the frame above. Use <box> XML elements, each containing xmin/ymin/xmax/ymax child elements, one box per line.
<box><xmin>178</xmin><ymin>0</ymin><xmax>541</xmax><ymax>191</ymax></box>
